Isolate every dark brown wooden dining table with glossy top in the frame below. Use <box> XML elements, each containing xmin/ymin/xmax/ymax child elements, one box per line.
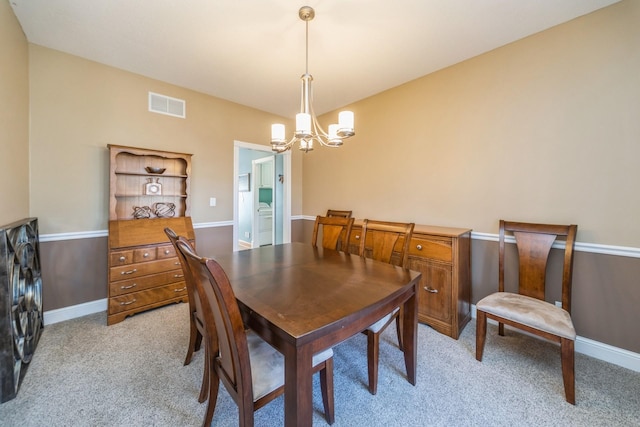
<box><xmin>213</xmin><ymin>243</ymin><xmax>421</xmax><ymax>427</ymax></box>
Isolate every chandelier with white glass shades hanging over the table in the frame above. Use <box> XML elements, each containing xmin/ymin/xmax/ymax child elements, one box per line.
<box><xmin>271</xmin><ymin>6</ymin><xmax>355</xmax><ymax>153</ymax></box>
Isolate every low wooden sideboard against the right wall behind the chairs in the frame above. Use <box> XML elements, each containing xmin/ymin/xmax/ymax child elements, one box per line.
<box><xmin>349</xmin><ymin>222</ymin><xmax>471</xmax><ymax>339</ymax></box>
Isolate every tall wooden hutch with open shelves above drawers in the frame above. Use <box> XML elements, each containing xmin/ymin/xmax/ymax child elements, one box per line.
<box><xmin>107</xmin><ymin>145</ymin><xmax>195</xmax><ymax>325</ymax></box>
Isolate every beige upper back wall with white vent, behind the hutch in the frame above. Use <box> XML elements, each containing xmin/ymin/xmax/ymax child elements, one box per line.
<box><xmin>29</xmin><ymin>45</ymin><xmax>302</xmax><ymax>234</ymax></box>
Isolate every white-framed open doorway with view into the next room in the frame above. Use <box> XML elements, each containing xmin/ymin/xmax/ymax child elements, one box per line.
<box><xmin>233</xmin><ymin>141</ymin><xmax>291</xmax><ymax>251</ymax></box>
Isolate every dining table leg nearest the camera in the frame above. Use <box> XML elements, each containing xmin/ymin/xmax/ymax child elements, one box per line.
<box><xmin>284</xmin><ymin>345</ymin><xmax>313</xmax><ymax>427</ymax></box>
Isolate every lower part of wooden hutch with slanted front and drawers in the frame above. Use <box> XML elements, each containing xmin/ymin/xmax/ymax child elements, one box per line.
<box><xmin>107</xmin><ymin>217</ymin><xmax>195</xmax><ymax>325</ymax></box>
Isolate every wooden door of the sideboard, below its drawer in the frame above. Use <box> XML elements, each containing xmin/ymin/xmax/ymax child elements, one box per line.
<box><xmin>408</xmin><ymin>257</ymin><xmax>452</xmax><ymax>323</ymax></box>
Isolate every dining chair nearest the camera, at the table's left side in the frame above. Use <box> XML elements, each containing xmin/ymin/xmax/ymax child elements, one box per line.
<box><xmin>177</xmin><ymin>238</ymin><xmax>334</xmax><ymax>427</ymax></box>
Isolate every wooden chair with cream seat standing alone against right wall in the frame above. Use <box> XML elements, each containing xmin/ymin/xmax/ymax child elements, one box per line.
<box><xmin>476</xmin><ymin>220</ymin><xmax>578</xmax><ymax>405</ymax></box>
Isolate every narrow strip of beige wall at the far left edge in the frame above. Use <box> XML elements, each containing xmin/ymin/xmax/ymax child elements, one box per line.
<box><xmin>0</xmin><ymin>1</ymin><xmax>29</xmax><ymax>226</ymax></box>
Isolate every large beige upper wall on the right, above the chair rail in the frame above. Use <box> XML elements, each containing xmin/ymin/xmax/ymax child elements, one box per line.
<box><xmin>303</xmin><ymin>0</ymin><xmax>640</xmax><ymax>248</ymax></box>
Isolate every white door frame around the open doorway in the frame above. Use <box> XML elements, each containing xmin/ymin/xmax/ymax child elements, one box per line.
<box><xmin>233</xmin><ymin>140</ymin><xmax>291</xmax><ymax>252</ymax></box>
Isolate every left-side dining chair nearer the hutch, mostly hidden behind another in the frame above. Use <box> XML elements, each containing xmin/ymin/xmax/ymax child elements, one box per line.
<box><xmin>164</xmin><ymin>227</ymin><xmax>209</xmax><ymax>403</ymax></box>
